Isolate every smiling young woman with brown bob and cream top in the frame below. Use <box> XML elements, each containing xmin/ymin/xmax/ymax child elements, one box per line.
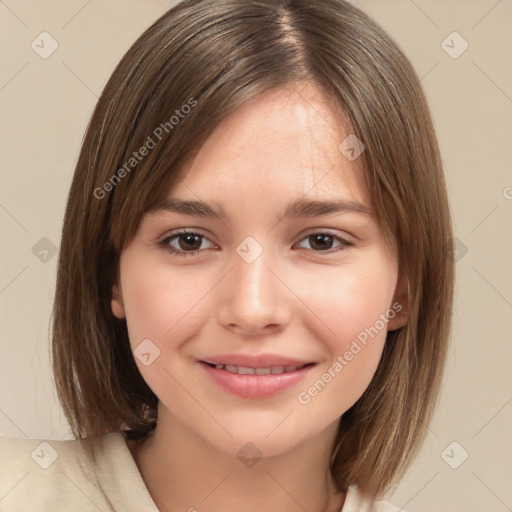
<box><xmin>0</xmin><ymin>0</ymin><xmax>454</xmax><ymax>512</ymax></box>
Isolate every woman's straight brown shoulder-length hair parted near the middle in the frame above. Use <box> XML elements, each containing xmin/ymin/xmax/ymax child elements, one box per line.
<box><xmin>52</xmin><ymin>0</ymin><xmax>454</xmax><ymax>495</ymax></box>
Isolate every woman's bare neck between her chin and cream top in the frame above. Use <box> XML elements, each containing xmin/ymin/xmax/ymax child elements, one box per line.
<box><xmin>128</xmin><ymin>411</ymin><xmax>345</xmax><ymax>512</ymax></box>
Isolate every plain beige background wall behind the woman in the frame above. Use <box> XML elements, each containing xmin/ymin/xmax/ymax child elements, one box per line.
<box><xmin>0</xmin><ymin>0</ymin><xmax>512</xmax><ymax>512</ymax></box>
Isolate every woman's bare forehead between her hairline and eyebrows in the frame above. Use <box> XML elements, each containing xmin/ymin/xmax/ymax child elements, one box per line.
<box><xmin>168</xmin><ymin>83</ymin><xmax>370</xmax><ymax>210</ymax></box>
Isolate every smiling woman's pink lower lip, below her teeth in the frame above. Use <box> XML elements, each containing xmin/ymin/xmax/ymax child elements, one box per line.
<box><xmin>199</xmin><ymin>362</ymin><xmax>315</xmax><ymax>400</ymax></box>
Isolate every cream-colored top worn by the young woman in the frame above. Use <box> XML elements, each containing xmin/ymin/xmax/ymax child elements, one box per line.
<box><xmin>0</xmin><ymin>432</ymin><xmax>399</xmax><ymax>512</ymax></box>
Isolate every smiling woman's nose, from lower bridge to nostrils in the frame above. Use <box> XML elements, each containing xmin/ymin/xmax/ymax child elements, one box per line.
<box><xmin>213</xmin><ymin>246</ymin><xmax>293</xmax><ymax>336</ymax></box>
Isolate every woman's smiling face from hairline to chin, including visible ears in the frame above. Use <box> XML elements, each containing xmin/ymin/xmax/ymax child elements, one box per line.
<box><xmin>112</xmin><ymin>84</ymin><xmax>405</xmax><ymax>455</ymax></box>
